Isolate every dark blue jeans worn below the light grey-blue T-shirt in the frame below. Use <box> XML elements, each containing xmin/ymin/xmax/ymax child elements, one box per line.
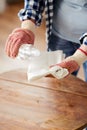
<box><xmin>48</xmin><ymin>34</ymin><xmax>87</xmax><ymax>81</ymax></box>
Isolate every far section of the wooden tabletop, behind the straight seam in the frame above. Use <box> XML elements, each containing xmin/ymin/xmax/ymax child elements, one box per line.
<box><xmin>0</xmin><ymin>69</ymin><xmax>87</xmax><ymax>96</ymax></box>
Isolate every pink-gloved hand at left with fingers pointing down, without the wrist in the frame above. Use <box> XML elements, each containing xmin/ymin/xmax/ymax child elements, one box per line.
<box><xmin>5</xmin><ymin>28</ymin><xmax>35</xmax><ymax>58</ymax></box>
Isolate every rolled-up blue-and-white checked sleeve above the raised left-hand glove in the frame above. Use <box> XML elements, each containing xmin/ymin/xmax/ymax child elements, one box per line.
<box><xmin>18</xmin><ymin>0</ymin><xmax>45</xmax><ymax>26</ymax></box>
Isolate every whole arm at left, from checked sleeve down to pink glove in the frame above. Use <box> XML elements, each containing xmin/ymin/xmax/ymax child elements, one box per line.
<box><xmin>5</xmin><ymin>0</ymin><xmax>44</xmax><ymax>58</ymax></box>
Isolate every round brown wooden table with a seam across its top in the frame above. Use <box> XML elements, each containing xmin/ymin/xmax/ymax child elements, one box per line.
<box><xmin>0</xmin><ymin>69</ymin><xmax>87</xmax><ymax>130</ymax></box>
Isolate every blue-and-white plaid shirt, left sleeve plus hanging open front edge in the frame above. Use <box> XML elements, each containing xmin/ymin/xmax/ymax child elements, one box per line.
<box><xmin>18</xmin><ymin>0</ymin><xmax>53</xmax><ymax>42</ymax></box>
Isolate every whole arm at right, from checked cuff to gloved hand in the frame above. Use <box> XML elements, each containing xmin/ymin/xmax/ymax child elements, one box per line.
<box><xmin>51</xmin><ymin>35</ymin><xmax>87</xmax><ymax>79</ymax></box>
